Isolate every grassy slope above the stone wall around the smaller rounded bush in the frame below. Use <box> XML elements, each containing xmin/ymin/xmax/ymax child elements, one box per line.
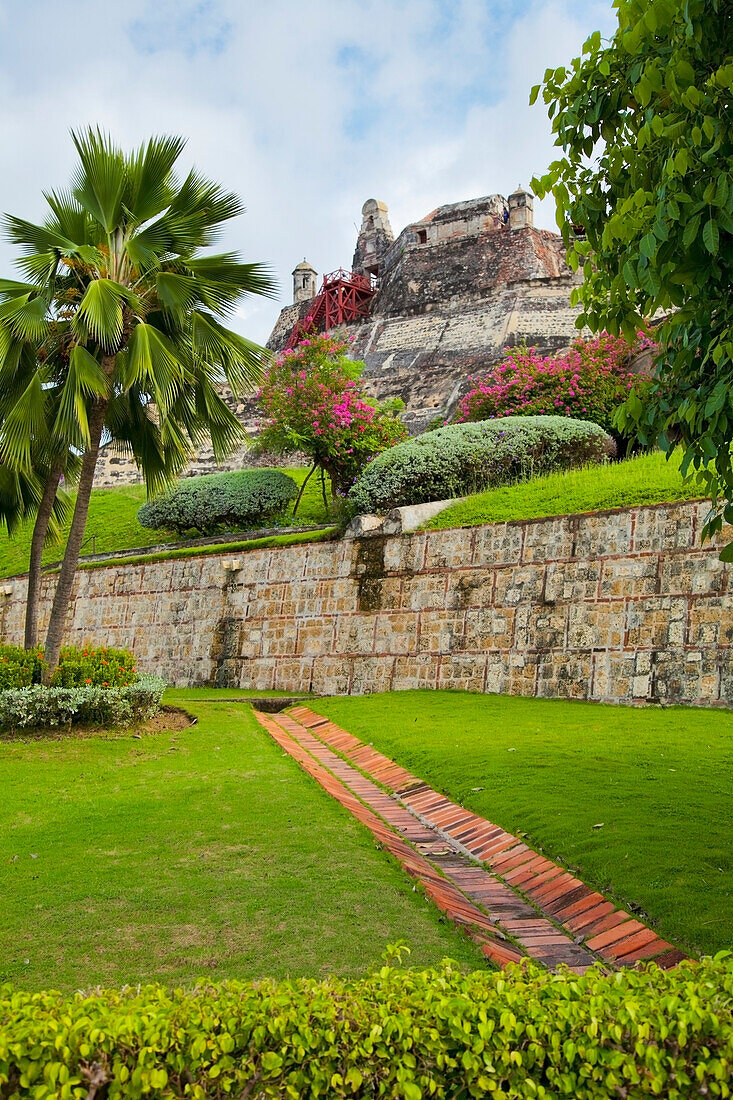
<box><xmin>0</xmin><ymin>468</ymin><xmax>329</xmax><ymax>576</ymax></box>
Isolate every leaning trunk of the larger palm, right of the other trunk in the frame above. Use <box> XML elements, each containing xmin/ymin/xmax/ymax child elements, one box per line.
<box><xmin>44</xmin><ymin>396</ymin><xmax>108</xmax><ymax>683</ymax></box>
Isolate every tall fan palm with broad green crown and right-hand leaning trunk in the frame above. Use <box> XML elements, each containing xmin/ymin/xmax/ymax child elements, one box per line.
<box><xmin>0</xmin><ymin>129</ymin><xmax>274</xmax><ymax>674</ymax></box>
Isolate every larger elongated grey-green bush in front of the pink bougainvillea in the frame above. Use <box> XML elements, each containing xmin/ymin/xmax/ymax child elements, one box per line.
<box><xmin>349</xmin><ymin>416</ymin><xmax>615</xmax><ymax>513</ymax></box>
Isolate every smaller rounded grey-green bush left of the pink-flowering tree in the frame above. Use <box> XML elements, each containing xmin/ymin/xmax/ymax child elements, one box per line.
<box><xmin>138</xmin><ymin>470</ymin><xmax>298</xmax><ymax>535</ymax></box>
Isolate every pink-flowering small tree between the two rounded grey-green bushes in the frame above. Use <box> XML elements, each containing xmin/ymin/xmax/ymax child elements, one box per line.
<box><xmin>260</xmin><ymin>332</ymin><xmax>407</xmax><ymax>493</ymax></box>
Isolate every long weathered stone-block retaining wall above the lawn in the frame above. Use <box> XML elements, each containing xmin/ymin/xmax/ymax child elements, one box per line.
<box><xmin>0</xmin><ymin>503</ymin><xmax>733</xmax><ymax>706</ymax></box>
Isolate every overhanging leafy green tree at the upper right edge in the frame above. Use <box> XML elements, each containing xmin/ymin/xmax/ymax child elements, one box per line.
<box><xmin>530</xmin><ymin>0</ymin><xmax>733</xmax><ymax>545</ymax></box>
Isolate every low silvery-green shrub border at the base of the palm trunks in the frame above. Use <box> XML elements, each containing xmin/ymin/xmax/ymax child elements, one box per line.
<box><xmin>0</xmin><ymin>675</ymin><xmax>166</xmax><ymax>730</ymax></box>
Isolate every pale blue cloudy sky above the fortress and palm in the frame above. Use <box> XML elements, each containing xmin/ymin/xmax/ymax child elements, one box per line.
<box><xmin>0</xmin><ymin>0</ymin><xmax>614</xmax><ymax>341</ymax></box>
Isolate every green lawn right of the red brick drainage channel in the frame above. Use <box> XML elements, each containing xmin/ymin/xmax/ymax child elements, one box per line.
<box><xmin>313</xmin><ymin>692</ymin><xmax>733</xmax><ymax>953</ymax></box>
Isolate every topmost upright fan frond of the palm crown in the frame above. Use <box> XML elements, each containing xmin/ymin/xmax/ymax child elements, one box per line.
<box><xmin>72</xmin><ymin>127</ymin><xmax>125</xmax><ymax>233</ymax></box>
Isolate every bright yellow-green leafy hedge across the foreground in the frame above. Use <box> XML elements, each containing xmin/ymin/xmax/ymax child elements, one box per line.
<box><xmin>0</xmin><ymin>955</ymin><xmax>733</xmax><ymax>1100</ymax></box>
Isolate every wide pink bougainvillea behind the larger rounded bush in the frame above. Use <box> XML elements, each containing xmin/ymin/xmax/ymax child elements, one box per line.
<box><xmin>455</xmin><ymin>332</ymin><xmax>658</xmax><ymax>431</ymax></box>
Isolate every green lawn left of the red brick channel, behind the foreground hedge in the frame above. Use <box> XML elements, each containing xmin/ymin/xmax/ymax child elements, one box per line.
<box><xmin>0</xmin><ymin>691</ymin><xmax>482</xmax><ymax>990</ymax></box>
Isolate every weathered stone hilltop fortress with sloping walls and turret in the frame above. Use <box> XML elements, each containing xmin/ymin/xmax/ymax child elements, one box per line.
<box><xmin>96</xmin><ymin>187</ymin><xmax>579</xmax><ymax>486</ymax></box>
